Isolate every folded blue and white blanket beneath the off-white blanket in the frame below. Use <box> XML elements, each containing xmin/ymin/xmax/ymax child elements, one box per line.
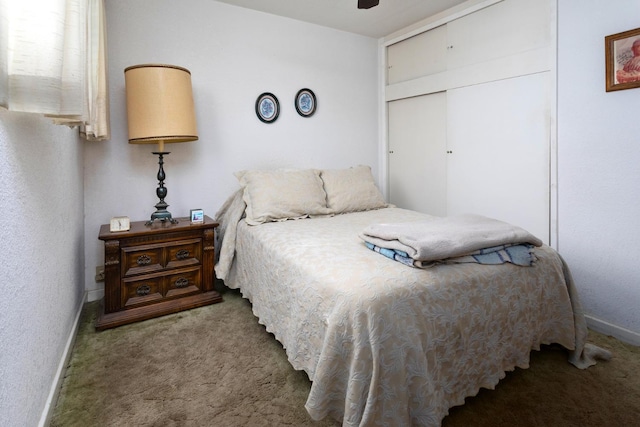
<box><xmin>364</xmin><ymin>241</ymin><xmax>536</xmax><ymax>268</ymax></box>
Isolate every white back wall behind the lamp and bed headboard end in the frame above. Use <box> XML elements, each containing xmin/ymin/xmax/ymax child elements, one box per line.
<box><xmin>85</xmin><ymin>0</ymin><xmax>378</xmax><ymax>299</ymax></box>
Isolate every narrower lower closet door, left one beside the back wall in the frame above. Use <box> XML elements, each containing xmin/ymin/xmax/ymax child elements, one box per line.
<box><xmin>388</xmin><ymin>92</ymin><xmax>447</xmax><ymax>216</ymax></box>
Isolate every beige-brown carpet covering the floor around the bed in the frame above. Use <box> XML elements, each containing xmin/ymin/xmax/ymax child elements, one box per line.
<box><xmin>51</xmin><ymin>290</ymin><xmax>640</xmax><ymax>427</ymax></box>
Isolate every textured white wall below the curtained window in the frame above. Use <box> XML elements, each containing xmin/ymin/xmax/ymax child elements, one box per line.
<box><xmin>0</xmin><ymin>109</ymin><xmax>86</xmax><ymax>427</ymax></box>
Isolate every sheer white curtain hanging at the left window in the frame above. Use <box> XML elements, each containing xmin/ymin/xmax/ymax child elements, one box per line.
<box><xmin>0</xmin><ymin>0</ymin><xmax>110</xmax><ymax>140</ymax></box>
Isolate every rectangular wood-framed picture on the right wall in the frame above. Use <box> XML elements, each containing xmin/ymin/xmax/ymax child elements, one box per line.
<box><xmin>604</xmin><ymin>28</ymin><xmax>640</xmax><ymax>92</ymax></box>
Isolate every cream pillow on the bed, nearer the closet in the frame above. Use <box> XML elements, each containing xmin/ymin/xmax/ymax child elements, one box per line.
<box><xmin>320</xmin><ymin>165</ymin><xmax>387</xmax><ymax>214</ymax></box>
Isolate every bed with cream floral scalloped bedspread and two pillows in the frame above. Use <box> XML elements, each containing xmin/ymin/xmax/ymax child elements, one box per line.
<box><xmin>216</xmin><ymin>166</ymin><xmax>606</xmax><ymax>426</ymax></box>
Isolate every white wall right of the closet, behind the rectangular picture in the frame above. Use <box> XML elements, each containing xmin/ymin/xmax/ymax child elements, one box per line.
<box><xmin>558</xmin><ymin>0</ymin><xmax>640</xmax><ymax>344</ymax></box>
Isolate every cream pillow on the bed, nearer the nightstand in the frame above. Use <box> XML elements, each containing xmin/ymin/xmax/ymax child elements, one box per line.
<box><xmin>235</xmin><ymin>169</ymin><xmax>330</xmax><ymax>225</ymax></box>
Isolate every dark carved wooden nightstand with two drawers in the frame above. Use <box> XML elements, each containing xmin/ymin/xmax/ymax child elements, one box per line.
<box><xmin>96</xmin><ymin>216</ymin><xmax>222</xmax><ymax>330</ymax></box>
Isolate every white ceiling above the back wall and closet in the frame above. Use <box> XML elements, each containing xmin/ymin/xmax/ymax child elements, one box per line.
<box><xmin>218</xmin><ymin>0</ymin><xmax>464</xmax><ymax>38</ymax></box>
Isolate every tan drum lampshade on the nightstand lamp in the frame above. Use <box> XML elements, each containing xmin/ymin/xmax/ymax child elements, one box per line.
<box><xmin>124</xmin><ymin>64</ymin><xmax>198</xmax><ymax>151</ymax></box>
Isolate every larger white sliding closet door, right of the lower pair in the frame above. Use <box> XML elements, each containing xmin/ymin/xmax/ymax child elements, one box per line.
<box><xmin>446</xmin><ymin>72</ymin><xmax>550</xmax><ymax>243</ymax></box>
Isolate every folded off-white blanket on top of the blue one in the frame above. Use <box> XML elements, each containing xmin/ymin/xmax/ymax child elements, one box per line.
<box><xmin>360</xmin><ymin>214</ymin><xmax>542</xmax><ymax>261</ymax></box>
